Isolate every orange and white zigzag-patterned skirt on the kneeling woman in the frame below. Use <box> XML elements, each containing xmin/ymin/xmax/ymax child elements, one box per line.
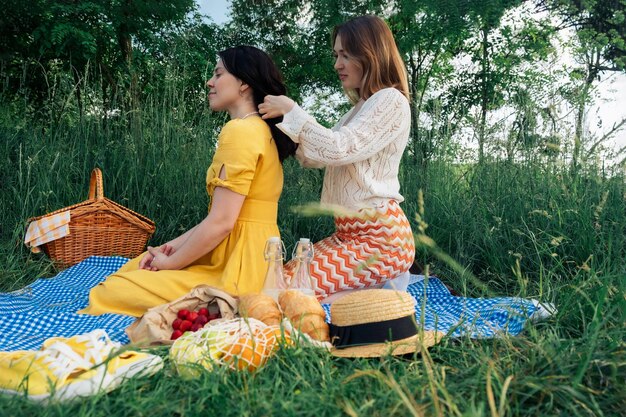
<box><xmin>285</xmin><ymin>200</ymin><xmax>415</xmax><ymax>298</ymax></box>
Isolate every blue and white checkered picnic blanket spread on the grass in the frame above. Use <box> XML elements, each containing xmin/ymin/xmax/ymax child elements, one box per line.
<box><xmin>0</xmin><ymin>256</ymin><xmax>539</xmax><ymax>351</ymax></box>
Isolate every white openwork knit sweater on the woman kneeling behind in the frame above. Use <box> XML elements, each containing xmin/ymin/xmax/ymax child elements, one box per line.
<box><xmin>278</xmin><ymin>88</ymin><xmax>411</xmax><ymax>209</ymax></box>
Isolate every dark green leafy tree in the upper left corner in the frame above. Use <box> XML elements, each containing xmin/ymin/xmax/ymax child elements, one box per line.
<box><xmin>0</xmin><ymin>0</ymin><xmax>195</xmax><ymax>118</ymax></box>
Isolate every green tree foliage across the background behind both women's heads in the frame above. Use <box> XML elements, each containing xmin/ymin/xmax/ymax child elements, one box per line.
<box><xmin>0</xmin><ymin>0</ymin><xmax>626</xmax><ymax>167</ymax></box>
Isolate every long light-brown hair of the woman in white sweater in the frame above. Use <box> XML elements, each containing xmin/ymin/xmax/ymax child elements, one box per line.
<box><xmin>332</xmin><ymin>15</ymin><xmax>409</xmax><ymax>103</ymax></box>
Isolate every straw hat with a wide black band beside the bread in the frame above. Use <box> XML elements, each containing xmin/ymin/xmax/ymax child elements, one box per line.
<box><xmin>330</xmin><ymin>289</ymin><xmax>444</xmax><ymax>358</ymax></box>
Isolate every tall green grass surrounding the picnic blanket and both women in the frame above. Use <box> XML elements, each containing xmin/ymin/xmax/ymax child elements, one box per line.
<box><xmin>0</xmin><ymin>95</ymin><xmax>626</xmax><ymax>417</ymax></box>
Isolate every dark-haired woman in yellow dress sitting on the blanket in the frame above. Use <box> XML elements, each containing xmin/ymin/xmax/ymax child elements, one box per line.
<box><xmin>80</xmin><ymin>46</ymin><xmax>296</xmax><ymax>316</ymax></box>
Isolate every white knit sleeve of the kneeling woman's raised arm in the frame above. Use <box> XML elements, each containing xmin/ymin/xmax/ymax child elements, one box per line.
<box><xmin>278</xmin><ymin>88</ymin><xmax>411</xmax><ymax>166</ymax></box>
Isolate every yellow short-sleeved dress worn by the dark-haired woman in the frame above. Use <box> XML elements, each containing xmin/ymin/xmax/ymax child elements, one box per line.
<box><xmin>79</xmin><ymin>117</ymin><xmax>283</xmax><ymax>317</ymax></box>
